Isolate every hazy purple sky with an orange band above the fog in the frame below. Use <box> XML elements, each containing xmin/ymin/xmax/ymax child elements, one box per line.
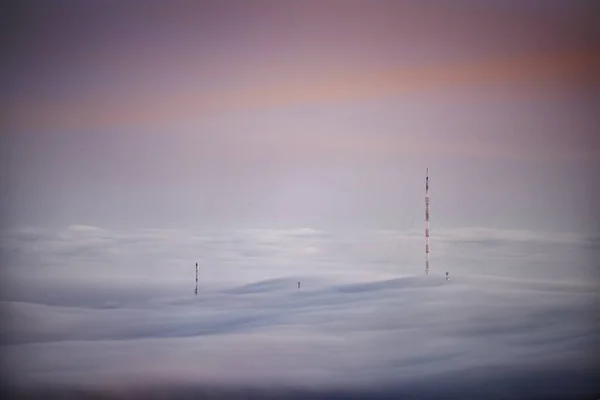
<box><xmin>1</xmin><ymin>1</ymin><xmax>600</xmax><ymax>232</ymax></box>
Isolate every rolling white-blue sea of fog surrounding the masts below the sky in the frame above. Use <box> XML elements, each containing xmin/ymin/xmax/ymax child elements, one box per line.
<box><xmin>0</xmin><ymin>226</ymin><xmax>600</xmax><ymax>399</ymax></box>
